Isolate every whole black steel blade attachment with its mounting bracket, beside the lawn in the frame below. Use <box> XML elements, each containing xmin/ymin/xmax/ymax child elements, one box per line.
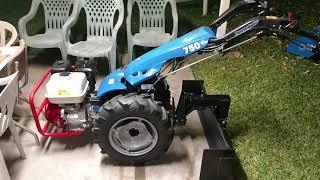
<box><xmin>175</xmin><ymin>80</ymin><xmax>235</xmax><ymax>180</ymax></box>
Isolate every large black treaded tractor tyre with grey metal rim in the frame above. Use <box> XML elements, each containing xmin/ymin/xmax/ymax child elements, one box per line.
<box><xmin>94</xmin><ymin>94</ymin><xmax>174</xmax><ymax>164</ymax></box>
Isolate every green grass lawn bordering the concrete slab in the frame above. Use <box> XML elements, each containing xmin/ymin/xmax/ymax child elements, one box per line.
<box><xmin>0</xmin><ymin>0</ymin><xmax>320</xmax><ymax>180</ymax></box>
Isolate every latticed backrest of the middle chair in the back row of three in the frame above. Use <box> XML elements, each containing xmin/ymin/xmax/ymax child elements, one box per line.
<box><xmin>81</xmin><ymin>0</ymin><xmax>124</xmax><ymax>37</ymax></box>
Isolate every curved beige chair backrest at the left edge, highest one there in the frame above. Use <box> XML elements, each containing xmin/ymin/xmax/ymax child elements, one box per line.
<box><xmin>0</xmin><ymin>21</ymin><xmax>18</xmax><ymax>47</ymax></box>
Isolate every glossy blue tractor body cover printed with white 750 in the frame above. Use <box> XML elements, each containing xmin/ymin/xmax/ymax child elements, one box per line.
<box><xmin>97</xmin><ymin>26</ymin><xmax>216</xmax><ymax>98</ymax></box>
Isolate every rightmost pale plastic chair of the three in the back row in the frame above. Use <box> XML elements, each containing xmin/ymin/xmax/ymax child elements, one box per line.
<box><xmin>127</xmin><ymin>0</ymin><xmax>178</xmax><ymax>61</ymax></box>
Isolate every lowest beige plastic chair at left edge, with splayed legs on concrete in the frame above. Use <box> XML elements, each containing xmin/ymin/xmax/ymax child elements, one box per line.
<box><xmin>0</xmin><ymin>72</ymin><xmax>39</xmax><ymax>158</ymax></box>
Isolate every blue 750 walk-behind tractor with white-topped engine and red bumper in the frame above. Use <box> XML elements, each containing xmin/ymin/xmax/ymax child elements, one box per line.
<box><xmin>29</xmin><ymin>0</ymin><xmax>320</xmax><ymax>169</ymax></box>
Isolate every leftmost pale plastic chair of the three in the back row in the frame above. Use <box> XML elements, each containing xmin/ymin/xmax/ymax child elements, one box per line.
<box><xmin>19</xmin><ymin>0</ymin><xmax>73</xmax><ymax>59</ymax></box>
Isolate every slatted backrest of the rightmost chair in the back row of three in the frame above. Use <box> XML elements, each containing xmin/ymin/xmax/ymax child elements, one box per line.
<box><xmin>132</xmin><ymin>0</ymin><xmax>169</xmax><ymax>32</ymax></box>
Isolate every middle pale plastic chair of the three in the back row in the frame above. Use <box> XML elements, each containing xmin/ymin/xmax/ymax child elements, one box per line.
<box><xmin>63</xmin><ymin>0</ymin><xmax>124</xmax><ymax>71</ymax></box>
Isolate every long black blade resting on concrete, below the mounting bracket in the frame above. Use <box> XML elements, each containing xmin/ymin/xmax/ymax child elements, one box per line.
<box><xmin>198</xmin><ymin>107</ymin><xmax>237</xmax><ymax>180</ymax></box>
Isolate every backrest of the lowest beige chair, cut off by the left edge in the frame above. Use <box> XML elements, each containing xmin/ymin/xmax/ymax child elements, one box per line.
<box><xmin>0</xmin><ymin>72</ymin><xmax>18</xmax><ymax>136</ymax></box>
